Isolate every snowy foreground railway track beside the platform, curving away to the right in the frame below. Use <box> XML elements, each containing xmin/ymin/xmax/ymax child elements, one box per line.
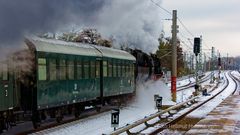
<box><xmin>110</xmin><ymin>72</ymin><xmax>238</xmax><ymax>135</ymax></box>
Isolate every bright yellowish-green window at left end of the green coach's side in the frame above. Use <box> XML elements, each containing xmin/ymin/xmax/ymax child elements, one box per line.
<box><xmin>38</xmin><ymin>58</ymin><xmax>47</xmax><ymax>81</ymax></box>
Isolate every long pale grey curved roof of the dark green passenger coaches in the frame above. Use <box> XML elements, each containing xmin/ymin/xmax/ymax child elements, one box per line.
<box><xmin>26</xmin><ymin>37</ymin><xmax>136</xmax><ymax>61</ymax></box>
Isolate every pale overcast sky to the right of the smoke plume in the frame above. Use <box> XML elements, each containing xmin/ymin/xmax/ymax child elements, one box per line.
<box><xmin>161</xmin><ymin>0</ymin><xmax>240</xmax><ymax>56</ymax></box>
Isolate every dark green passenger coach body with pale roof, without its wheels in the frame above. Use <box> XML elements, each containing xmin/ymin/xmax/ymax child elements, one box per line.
<box><xmin>26</xmin><ymin>37</ymin><xmax>135</xmax><ymax>110</ymax></box>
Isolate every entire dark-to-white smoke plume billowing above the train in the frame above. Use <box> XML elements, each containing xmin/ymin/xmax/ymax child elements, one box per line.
<box><xmin>0</xmin><ymin>0</ymin><xmax>161</xmax><ymax>57</ymax></box>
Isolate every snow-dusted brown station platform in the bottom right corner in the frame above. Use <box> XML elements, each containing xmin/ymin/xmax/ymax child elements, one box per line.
<box><xmin>186</xmin><ymin>95</ymin><xmax>240</xmax><ymax>135</ymax></box>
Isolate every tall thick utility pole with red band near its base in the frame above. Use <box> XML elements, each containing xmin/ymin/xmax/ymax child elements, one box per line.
<box><xmin>171</xmin><ymin>10</ymin><xmax>178</xmax><ymax>102</ymax></box>
